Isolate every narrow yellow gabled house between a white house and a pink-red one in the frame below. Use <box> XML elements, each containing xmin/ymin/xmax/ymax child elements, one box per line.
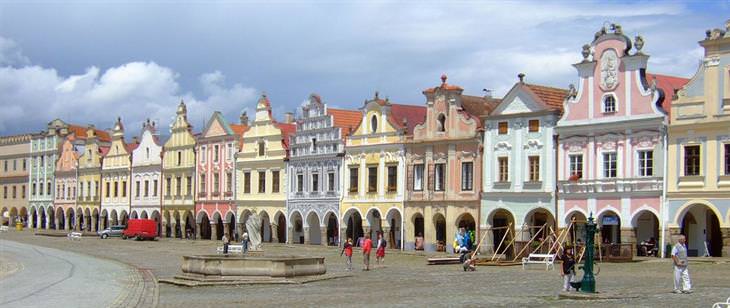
<box><xmin>162</xmin><ymin>102</ymin><xmax>195</xmax><ymax>238</ymax></box>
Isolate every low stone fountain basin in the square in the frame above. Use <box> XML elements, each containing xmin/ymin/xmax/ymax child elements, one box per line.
<box><xmin>181</xmin><ymin>255</ymin><xmax>327</xmax><ymax>278</ymax></box>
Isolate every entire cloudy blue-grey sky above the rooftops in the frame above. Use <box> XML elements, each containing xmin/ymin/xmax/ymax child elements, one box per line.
<box><xmin>0</xmin><ymin>1</ymin><xmax>730</xmax><ymax>135</ymax></box>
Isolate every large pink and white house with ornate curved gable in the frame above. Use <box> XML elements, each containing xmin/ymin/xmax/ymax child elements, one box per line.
<box><xmin>556</xmin><ymin>24</ymin><xmax>673</xmax><ymax>256</ymax></box>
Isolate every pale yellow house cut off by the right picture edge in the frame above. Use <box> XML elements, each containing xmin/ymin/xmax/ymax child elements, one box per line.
<box><xmin>663</xmin><ymin>21</ymin><xmax>730</xmax><ymax>257</ymax></box>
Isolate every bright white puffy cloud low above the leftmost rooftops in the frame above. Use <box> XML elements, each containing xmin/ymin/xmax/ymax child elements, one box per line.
<box><xmin>0</xmin><ymin>38</ymin><xmax>257</xmax><ymax>135</ymax></box>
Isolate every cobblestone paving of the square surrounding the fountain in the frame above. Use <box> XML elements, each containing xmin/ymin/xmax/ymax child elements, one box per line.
<box><xmin>0</xmin><ymin>231</ymin><xmax>730</xmax><ymax>307</ymax></box>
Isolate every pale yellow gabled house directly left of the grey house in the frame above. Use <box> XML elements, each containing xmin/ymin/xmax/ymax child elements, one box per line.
<box><xmin>236</xmin><ymin>95</ymin><xmax>296</xmax><ymax>242</ymax></box>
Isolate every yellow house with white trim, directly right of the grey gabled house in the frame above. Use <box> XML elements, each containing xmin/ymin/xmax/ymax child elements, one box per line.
<box><xmin>340</xmin><ymin>93</ymin><xmax>425</xmax><ymax>248</ymax></box>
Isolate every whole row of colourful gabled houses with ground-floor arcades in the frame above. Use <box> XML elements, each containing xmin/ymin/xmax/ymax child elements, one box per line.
<box><xmin>0</xmin><ymin>25</ymin><xmax>730</xmax><ymax>256</ymax></box>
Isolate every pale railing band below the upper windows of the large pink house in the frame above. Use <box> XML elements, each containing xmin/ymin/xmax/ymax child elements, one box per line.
<box><xmin>558</xmin><ymin>177</ymin><xmax>662</xmax><ymax>194</ymax></box>
